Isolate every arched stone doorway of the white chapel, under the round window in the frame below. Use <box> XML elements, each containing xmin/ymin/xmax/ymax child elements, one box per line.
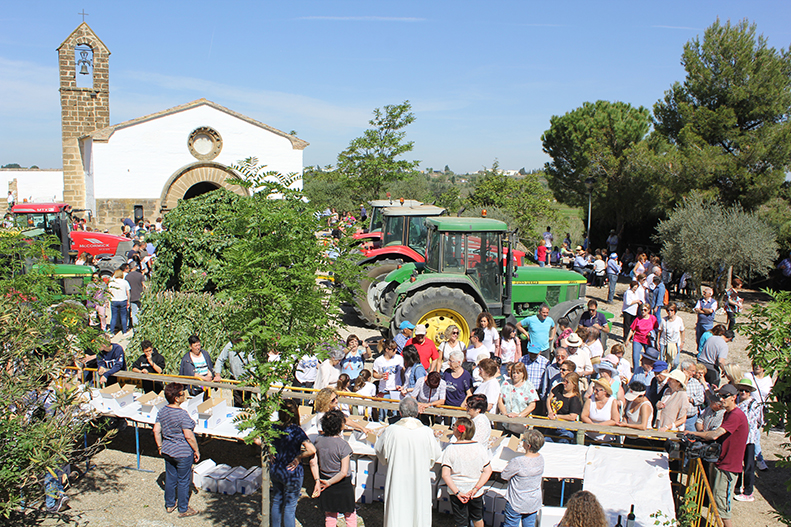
<box><xmin>160</xmin><ymin>162</ymin><xmax>249</xmax><ymax>212</ymax></box>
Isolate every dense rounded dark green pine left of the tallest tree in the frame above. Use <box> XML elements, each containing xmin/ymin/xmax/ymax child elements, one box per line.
<box><xmin>541</xmin><ymin>101</ymin><xmax>653</xmax><ymax>236</ymax></box>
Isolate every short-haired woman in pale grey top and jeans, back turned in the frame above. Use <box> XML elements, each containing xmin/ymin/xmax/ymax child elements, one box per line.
<box><xmin>500</xmin><ymin>430</ymin><xmax>544</xmax><ymax>527</ymax></box>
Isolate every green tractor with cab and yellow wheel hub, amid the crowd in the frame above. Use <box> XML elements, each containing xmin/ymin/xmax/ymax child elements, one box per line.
<box><xmin>377</xmin><ymin>216</ymin><xmax>586</xmax><ymax>342</ymax></box>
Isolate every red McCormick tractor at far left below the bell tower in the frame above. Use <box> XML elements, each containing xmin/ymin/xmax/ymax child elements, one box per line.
<box><xmin>11</xmin><ymin>203</ymin><xmax>132</xmax><ymax>276</ymax></box>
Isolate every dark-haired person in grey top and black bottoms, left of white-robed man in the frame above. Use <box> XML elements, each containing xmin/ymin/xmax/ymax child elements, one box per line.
<box><xmin>313</xmin><ymin>410</ymin><xmax>357</xmax><ymax>527</ymax></box>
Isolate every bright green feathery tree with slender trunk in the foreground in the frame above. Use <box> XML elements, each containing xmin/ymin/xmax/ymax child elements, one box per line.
<box><xmin>213</xmin><ymin>161</ymin><xmax>359</xmax><ymax>526</ymax></box>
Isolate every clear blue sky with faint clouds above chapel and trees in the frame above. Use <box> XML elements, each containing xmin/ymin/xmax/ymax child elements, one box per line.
<box><xmin>0</xmin><ymin>0</ymin><xmax>791</xmax><ymax>172</ymax></box>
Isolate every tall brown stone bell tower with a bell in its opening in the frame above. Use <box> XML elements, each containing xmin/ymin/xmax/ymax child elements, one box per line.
<box><xmin>57</xmin><ymin>22</ymin><xmax>110</xmax><ymax>209</ymax></box>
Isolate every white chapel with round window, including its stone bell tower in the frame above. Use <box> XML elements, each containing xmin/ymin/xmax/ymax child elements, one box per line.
<box><xmin>57</xmin><ymin>22</ymin><xmax>308</xmax><ymax>232</ymax></box>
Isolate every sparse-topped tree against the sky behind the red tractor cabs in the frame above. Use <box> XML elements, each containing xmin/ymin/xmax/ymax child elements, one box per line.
<box><xmin>338</xmin><ymin>101</ymin><xmax>420</xmax><ymax>200</ymax></box>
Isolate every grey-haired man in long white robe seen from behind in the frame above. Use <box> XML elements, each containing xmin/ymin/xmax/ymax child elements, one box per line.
<box><xmin>375</xmin><ymin>397</ymin><xmax>442</xmax><ymax>527</ymax></box>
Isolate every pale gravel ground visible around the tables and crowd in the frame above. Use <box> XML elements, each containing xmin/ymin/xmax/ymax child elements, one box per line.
<box><xmin>13</xmin><ymin>284</ymin><xmax>791</xmax><ymax>527</ymax></box>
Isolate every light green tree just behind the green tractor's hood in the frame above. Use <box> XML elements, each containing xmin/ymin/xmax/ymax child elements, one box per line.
<box><xmin>467</xmin><ymin>160</ymin><xmax>559</xmax><ymax>245</ymax></box>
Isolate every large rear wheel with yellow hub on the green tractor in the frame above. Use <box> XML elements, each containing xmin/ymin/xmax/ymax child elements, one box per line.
<box><xmin>393</xmin><ymin>286</ymin><xmax>483</xmax><ymax>345</ymax></box>
